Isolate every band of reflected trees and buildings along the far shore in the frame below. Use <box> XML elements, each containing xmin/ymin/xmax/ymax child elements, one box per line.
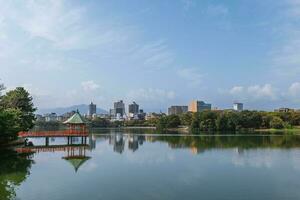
<box><xmin>12</xmin><ymin>133</ymin><xmax>300</xmax><ymax>157</ymax></box>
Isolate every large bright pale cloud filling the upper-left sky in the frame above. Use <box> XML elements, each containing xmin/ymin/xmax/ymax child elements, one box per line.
<box><xmin>0</xmin><ymin>0</ymin><xmax>137</xmax><ymax>71</ymax></box>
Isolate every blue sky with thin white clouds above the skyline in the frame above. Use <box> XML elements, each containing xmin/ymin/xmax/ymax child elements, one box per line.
<box><xmin>0</xmin><ymin>0</ymin><xmax>300</xmax><ymax>112</ymax></box>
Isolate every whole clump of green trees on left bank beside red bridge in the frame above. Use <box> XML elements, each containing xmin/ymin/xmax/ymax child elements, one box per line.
<box><xmin>0</xmin><ymin>84</ymin><xmax>36</xmax><ymax>143</ymax></box>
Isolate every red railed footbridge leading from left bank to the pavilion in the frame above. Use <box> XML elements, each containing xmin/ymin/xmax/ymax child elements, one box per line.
<box><xmin>18</xmin><ymin>130</ymin><xmax>88</xmax><ymax>138</ymax></box>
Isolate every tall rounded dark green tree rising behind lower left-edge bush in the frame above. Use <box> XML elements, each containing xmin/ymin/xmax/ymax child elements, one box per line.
<box><xmin>0</xmin><ymin>87</ymin><xmax>36</xmax><ymax>131</ymax></box>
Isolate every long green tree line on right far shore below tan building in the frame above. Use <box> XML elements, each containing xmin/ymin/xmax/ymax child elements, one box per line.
<box><xmin>156</xmin><ymin>110</ymin><xmax>300</xmax><ymax>131</ymax></box>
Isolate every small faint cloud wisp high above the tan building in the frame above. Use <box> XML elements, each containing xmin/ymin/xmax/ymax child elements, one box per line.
<box><xmin>176</xmin><ymin>68</ymin><xmax>203</xmax><ymax>87</ymax></box>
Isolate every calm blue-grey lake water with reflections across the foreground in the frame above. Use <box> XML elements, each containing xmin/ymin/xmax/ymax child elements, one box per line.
<box><xmin>0</xmin><ymin>130</ymin><xmax>300</xmax><ymax>200</ymax></box>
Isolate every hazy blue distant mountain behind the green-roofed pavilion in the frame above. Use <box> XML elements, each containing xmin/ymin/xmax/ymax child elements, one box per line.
<box><xmin>36</xmin><ymin>104</ymin><xmax>108</xmax><ymax>115</ymax></box>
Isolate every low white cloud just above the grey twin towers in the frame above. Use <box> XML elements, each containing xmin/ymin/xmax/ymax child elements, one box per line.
<box><xmin>127</xmin><ymin>88</ymin><xmax>175</xmax><ymax>102</ymax></box>
